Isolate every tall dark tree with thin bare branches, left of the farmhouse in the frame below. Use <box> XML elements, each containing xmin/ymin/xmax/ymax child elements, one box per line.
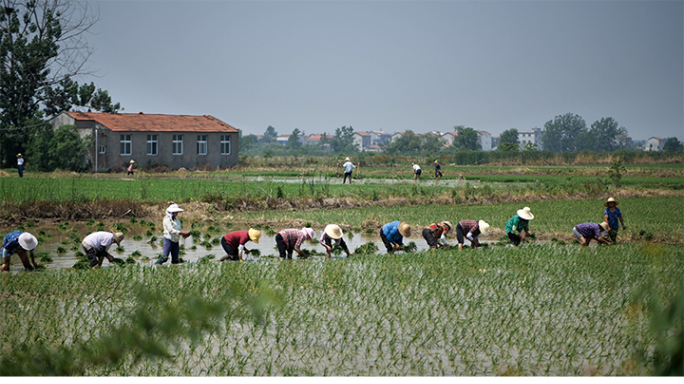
<box><xmin>0</xmin><ymin>0</ymin><xmax>122</xmax><ymax>166</ymax></box>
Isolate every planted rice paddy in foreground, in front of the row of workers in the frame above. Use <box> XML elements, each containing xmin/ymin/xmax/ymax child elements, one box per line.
<box><xmin>0</xmin><ymin>245</ymin><xmax>684</xmax><ymax>376</ymax></box>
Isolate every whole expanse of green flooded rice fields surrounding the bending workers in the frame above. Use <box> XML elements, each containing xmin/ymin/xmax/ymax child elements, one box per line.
<box><xmin>0</xmin><ymin>164</ymin><xmax>684</xmax><ymax>376</ymax></box>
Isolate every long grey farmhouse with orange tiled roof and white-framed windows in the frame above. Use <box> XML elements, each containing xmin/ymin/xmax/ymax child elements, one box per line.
<box><xmin>50</xmin><ymin>112</ymin><xmax>239</xmax><ymax>172</ymax></box>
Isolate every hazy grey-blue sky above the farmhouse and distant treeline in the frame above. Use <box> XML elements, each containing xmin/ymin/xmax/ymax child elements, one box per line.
<box><xmin>81</xmin><ymin>0</ymin><xmax>684</xmax><ymax>139</ymax></box>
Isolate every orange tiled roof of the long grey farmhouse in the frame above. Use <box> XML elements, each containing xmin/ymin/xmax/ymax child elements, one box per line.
<box><xmin>66</xmin><ymin>112</ymin><xmax>238</xmax><ymax>132</ymax></box>
